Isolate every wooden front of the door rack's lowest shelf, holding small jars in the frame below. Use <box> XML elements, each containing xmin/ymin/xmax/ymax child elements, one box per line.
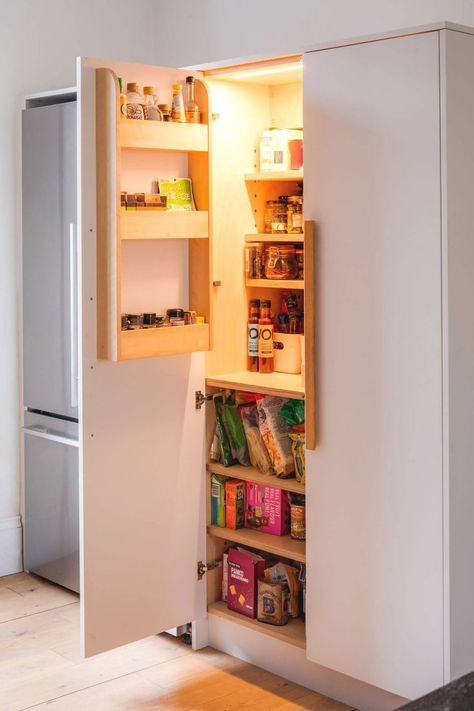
<box><xmin>119</xmin><ymin>323</ymin><xmax>209</xmax><ymax>360</ymax></box>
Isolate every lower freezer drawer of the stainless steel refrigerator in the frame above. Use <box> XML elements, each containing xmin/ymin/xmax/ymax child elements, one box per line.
<box><xmin>24</xmin><ymin>418</ymin><xmax>79</xmax><ymax>592</ymax></box>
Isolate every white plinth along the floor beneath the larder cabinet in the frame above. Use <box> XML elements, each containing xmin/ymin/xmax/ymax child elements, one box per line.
<box><xmin>208</xmin><ymin>615</ymin><xmax>406</xmax><ymax>711</ymax></box>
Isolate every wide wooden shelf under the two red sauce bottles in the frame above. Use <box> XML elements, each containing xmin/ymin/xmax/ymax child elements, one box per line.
<box><xmin>206</xmin><ymin>370</ymin><xmax>304</xmax><ymax>400</ymax></box>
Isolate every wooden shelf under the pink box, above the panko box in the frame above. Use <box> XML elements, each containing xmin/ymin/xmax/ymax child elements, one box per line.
<box><xmin>207</xmin><ymin>526</ymin><xmax>306</xmax><ymax>563</ymax></box>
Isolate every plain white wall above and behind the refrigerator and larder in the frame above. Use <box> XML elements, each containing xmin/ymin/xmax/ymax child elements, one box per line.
<box><xmin>0</xmin><ymin>0</ymin><xmax>474</xmax><ymax>575</ymax></box>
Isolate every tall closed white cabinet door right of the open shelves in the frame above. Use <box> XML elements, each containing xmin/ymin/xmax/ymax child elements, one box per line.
<box><xmin>304</xmin><ymin>33</ymin><xmax>443</xmax><ymax>697</ymax></box>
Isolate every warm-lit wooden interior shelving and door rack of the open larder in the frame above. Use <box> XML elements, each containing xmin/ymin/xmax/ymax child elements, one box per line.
<box><xmin>96</xmin><ymin>56</ymin><xmax>316</xmax><ymax>648</ymax></box>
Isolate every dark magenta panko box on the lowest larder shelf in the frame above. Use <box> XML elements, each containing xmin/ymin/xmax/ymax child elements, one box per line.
<box><xmin>227</xmin><ymin>548</ymin><xmax>266</xmax><ymax>617</ymax></box>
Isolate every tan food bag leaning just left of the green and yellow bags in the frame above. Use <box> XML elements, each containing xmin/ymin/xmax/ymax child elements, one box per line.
<box><xmin>257</xmin><ymin>396</ymin><xmax>294</xmax><ymax>479</ymax></box>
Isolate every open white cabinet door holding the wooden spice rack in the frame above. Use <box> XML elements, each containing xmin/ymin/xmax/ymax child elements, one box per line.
<box><xmin>78</xmin><ymin>59</ymin><xmax>205</xmax><ymax>656</ymax></box>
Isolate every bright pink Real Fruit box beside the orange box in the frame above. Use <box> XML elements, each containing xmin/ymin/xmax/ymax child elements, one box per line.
<box><xmin>245</xmin><ymin>481</ymin><xmax>290</xmax><ymax>536</ymax></box>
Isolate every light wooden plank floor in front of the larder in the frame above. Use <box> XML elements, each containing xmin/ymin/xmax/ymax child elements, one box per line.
<box><xmin>0</xmin><ymin>573</ymin><xmax>349</xmax><ymax>711</ymax></box>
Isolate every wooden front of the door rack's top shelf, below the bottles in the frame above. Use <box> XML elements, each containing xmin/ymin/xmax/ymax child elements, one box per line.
<box><xmin>118</xmin><ymin>119</ymin><xmax>209</xmax><ymax>152</ymax></box>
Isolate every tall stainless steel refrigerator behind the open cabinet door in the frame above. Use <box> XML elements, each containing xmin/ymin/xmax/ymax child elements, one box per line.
<box><xmin>22</xmin><ymin>101</ymin><xmax>79</xmax><ymax>591</ymax></box>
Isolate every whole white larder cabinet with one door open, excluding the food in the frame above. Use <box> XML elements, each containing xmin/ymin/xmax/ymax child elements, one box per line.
<box><xmin>42</xmin><ymin>25</ymin><xmax>474</xmax><ymax>709</ymax></box>
